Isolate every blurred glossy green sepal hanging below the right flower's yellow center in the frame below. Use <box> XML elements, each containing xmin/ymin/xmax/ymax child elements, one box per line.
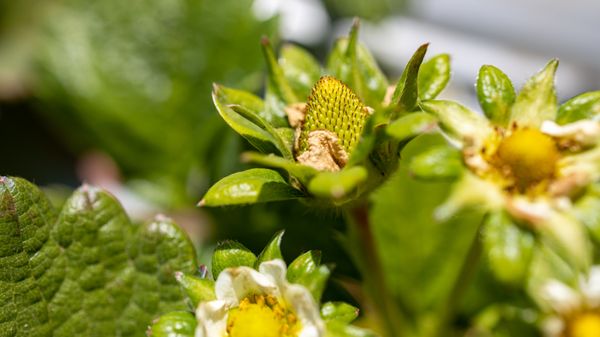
<box><xmin>482</xmin><ymin>211</ymin><xmax>536</xmax><ymax>286</ymax></box>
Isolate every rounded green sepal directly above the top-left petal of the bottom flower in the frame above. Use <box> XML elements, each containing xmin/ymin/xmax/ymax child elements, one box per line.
<box><xmin>212</xmin><ymin>240</ymin><xmax>257</xmax><ymax>280</ymax></box>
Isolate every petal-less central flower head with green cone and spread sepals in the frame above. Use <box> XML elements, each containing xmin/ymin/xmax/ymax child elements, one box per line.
<box><xmin>200</xmin><ymin>22</ymin><xmax>450</xmax><ymax>206</ymax></box>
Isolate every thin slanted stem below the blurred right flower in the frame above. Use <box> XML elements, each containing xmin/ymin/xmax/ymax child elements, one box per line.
<box><xmin>431</xmin><ymin>216</ymin><xmax>487</xmax><ymax>337</ymax></box>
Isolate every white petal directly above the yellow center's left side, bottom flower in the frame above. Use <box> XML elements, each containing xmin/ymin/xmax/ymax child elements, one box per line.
<box><xmin>215</xmin><ymin>267</ymin><xmax>281</xmax><ymax>305</ymax></box>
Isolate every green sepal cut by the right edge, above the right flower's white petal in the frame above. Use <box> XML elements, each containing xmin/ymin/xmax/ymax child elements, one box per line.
<box><xmin>556</xmin><ymin>91</ymin><xmax>600</xmax><ymax>125</ymax></box>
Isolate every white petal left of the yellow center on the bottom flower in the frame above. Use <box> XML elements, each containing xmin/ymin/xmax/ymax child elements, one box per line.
<box><xmin>195</xmin><ymin>300</ymin><xmax>230</xmax><ymax>337</ymax></box>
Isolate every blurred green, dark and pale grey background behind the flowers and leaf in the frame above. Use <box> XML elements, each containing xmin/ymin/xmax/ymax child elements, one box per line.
<box><xmin>0</xmin><ymin>0</ymin><xmax>600</xmax><ymax>275</ymax></box>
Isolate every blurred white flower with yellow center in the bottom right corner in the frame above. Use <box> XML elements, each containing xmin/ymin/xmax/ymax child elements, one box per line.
<box><xmin>541</xmin><ymin>266</ymin><xmax>600</xmax><ymax>337</ymax></box>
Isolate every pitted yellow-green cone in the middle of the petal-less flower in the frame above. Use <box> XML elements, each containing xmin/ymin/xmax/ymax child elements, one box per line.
<box><xmin>298</xmin><ymin>76</ymin><xmax>369</xmax><ymax>153</ymax></box>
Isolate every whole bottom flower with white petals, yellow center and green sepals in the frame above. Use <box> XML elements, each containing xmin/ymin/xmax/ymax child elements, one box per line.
<box><xmin>148</xmin><ymin>232</ymin><xmax>374</xmax><ymax>337</ymax></box>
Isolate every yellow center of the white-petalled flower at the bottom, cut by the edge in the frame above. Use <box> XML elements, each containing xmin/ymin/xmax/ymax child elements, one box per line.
<box><xmin>227</xmin><ymin>295</ymin><xmax>300</xmax><ymax>337</ymax></box>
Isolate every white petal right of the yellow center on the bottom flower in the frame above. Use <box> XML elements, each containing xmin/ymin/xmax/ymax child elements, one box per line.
<box><xmin>284</xmin><ymin>284</ymin><xmax>325</xmax><ymax>337</ymax></box>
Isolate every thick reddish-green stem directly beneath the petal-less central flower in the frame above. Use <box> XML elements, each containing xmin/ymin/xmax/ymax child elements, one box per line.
<box><xmin>346</xmin><ymin>203</ymin><xmax>408</xmax><ymax>337</ymax></box>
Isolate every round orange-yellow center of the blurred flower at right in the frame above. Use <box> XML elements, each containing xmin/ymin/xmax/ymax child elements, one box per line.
<box><xmin>496</xmin><ymin>128</ymin><xmax>560</xmax><ymax>192</ymax></box>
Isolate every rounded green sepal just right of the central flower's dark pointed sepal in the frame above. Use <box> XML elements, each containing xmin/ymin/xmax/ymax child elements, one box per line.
<box><xmin>418</xmin><ymin>54</ymin><xmax>450</xmax><ymax>100</ymax></box>
